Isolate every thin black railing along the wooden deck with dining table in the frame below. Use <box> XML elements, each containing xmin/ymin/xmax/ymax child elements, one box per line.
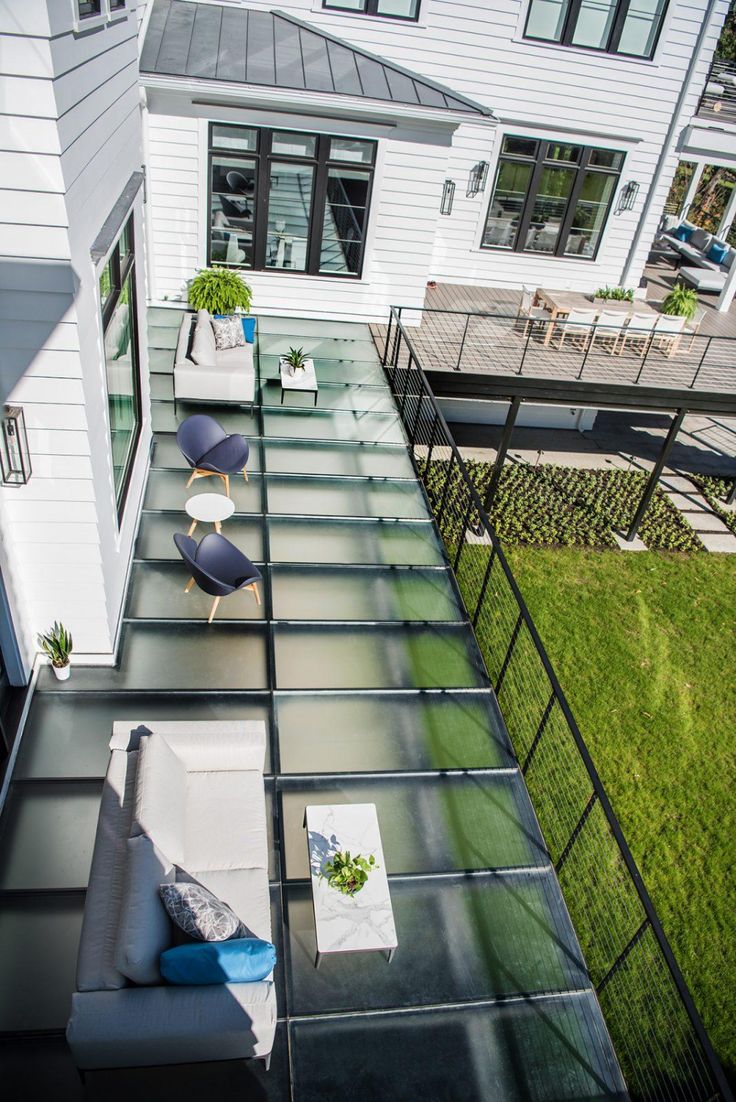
<box><xmin>386</xmin><ymin>302</ymin><xmax>736</xmax><ymax>393</ymax></box>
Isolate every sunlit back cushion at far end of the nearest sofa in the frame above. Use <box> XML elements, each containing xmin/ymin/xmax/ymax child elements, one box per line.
<box><xmin>130</xmin><ymin>734</ymin><xmax>186</xmax><ymax>864</ymax></box>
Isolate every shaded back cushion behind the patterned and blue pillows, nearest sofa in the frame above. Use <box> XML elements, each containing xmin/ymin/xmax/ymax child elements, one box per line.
<box><xmin>115</xmin><ymin>834</ymin><xmax>175</xmax><ymax>984</ymax></box>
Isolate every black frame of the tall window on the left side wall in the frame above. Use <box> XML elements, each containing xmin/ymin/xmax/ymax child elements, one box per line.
<box><xmin>98</xmin><ymin>218</ymin><xmax>143</xmax><ymax>526</ymax></box>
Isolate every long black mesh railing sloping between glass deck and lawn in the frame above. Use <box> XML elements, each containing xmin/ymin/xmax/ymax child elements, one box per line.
<box><xmin>383</xmin><ymin>308</ymin><xmax>733</xmax><ymax>1102</ymax></box>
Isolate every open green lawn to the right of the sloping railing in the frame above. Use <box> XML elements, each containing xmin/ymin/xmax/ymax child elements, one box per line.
<box><xmin>508</xmin><ymin>547</ymin><xmax>736</xmax><ymax>1078</ymax></box>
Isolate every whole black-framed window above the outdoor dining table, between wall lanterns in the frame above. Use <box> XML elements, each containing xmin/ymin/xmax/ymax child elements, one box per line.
<box><xmin>480</xmin><ymin>134</ymin><xmax>624</xmax><ymax>260</ymax></box>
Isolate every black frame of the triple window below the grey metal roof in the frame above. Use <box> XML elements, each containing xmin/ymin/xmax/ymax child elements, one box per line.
<box><xmin>206</xmin><ymin>122</ymin><xmax>378</xmax><ymax>280</ymax></box>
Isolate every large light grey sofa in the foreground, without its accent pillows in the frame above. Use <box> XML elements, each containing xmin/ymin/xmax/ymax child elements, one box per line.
<box><xmin>66</xmin><ymin>721</ymin><xmax>277</xmax><ymax>1071</ymax></box>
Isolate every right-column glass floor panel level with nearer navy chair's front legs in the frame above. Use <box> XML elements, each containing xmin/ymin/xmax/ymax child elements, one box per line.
<box><xmin>271</xmin><ymin>566</ymin><xmax>463</xmax><ymax>622</ymax></box>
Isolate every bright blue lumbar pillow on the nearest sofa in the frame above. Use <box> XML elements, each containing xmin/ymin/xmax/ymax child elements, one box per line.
<box><xmin>159</xmin><ymin>938</ymin><xmax>275</xmax><ymax>986</ymax></box>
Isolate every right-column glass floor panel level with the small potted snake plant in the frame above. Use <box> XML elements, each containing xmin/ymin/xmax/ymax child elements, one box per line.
<box><xmin>274</xmin><ymin>624</ymin><xmax>488</xmax><ymax>689</ymax></box>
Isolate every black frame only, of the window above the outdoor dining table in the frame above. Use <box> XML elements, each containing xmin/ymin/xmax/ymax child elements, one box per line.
<box><xmin>480</xmin><ymin>133</ymin><xmax>626</xmax><ymax>263</ymax></box>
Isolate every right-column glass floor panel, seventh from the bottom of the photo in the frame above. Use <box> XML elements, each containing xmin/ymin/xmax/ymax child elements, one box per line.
<box><xmin>268</xmin><ymin>517</ymin><xmax>444</xmax><ymax>566</ymax></box>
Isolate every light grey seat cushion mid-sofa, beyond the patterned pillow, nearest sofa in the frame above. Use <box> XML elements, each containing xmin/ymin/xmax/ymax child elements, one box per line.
<box><xmin>184</xmin><ymin>770</ymin><xmax>268</xmax><ymax>872</ymax></box>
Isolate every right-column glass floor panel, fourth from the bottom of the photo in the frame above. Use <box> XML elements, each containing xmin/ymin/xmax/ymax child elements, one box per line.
<box><xmin>275</xmin><ymin>693</ymin><xmax>513</xmax><ymax>774</ymax></box>
